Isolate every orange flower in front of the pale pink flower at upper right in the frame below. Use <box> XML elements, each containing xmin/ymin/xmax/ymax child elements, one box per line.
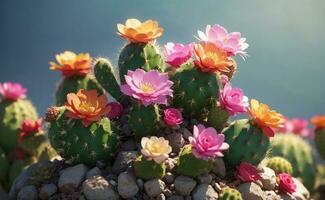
<box><xmin>194</xmin><ymin>42</ymin><xmax>235</xmax><ymax>73</ymax></box>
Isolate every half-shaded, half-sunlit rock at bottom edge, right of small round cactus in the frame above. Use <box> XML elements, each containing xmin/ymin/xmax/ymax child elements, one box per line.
<box><xmin>237</xmin><ymin>182</ymin><xmax>265</xmax><ymax>200</ymax></box>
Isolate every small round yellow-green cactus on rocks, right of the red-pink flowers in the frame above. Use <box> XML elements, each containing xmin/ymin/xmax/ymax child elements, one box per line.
<box><xmin>266</xmin><ymin>156</ymin><xmax>292</xmax><ymax>175</ymax></box>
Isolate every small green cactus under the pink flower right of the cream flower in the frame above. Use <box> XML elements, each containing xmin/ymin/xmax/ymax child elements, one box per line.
<box><xmin>177</xmin><ymin>145</ymin><xmax>213</xmax><ymax>177</ymax></box>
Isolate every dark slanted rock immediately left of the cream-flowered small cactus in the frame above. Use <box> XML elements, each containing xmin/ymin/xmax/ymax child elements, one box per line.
<box><xmin>112</xmin><ymin>151</ymin><xmax>138</xmax><ymax>174</ymax></box>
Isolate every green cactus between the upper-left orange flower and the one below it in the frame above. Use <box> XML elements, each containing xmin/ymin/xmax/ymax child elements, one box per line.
<box><xmin>55</xmin><ymin>75</ymin><xmax>104</xmax><ymax>106</ymax></box>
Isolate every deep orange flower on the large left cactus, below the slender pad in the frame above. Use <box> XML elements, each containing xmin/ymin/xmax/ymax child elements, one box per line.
<box><xmin>65</xmin><ymin>90</ymin><xmax>110</xmax><ymax>127</ymax></box>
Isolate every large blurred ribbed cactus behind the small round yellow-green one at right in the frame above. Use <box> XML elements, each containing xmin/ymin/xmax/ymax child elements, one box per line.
<box><xmin>271</xmin><ymin>133</ymin><xmax>316</xmax><ymax>190</ymax></box>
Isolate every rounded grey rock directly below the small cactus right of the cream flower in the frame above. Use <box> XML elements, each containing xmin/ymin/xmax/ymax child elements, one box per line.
<box><xmin>174</xmin><ymin>176</ymin><xmax>196</xmax><ymax>196</ymax></box>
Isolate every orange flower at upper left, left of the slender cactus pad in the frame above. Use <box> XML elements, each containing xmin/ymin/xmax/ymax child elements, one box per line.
<box><xmin>50</xmin><ymin>51</ymin><xmax>92</xmax><ymax>77</ymax></box>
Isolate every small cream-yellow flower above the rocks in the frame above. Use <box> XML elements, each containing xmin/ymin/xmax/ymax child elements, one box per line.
<box><xmin>141</xmin><ymin>136</ymin><xmax>172</xmax><ymax>164</ymax></box>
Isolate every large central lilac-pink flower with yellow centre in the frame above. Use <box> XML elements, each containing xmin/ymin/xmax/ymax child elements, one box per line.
<box><xmin>121</xmin><ymin>69</ymin><xmax>173</xmax><ymax>106</ymax></box>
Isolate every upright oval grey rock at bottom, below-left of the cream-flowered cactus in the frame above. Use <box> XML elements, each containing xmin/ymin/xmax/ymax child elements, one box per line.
<box><xmin>117</xmin><ymin>172</ymin><xmax>139</xmax><ymax>199</ymax></box>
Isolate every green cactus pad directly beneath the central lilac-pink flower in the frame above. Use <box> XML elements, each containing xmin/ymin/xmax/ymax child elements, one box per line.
<box><xmin>129</xmin><ymin>103</ymin><xmax>160</xmax><ymax>140</ymax></box>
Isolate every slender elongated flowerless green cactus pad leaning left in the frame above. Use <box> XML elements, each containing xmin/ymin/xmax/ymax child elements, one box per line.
<box><xmin>94</xmin><ymin>58</ymin><xmax>122</xmax><ymax>100</ymax></box>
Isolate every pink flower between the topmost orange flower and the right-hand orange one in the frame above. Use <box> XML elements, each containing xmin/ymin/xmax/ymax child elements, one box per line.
<box><xmin>163</xmin><ymin>42</ymin><xmax>193</xmax><ymax>68</ymax></box>
